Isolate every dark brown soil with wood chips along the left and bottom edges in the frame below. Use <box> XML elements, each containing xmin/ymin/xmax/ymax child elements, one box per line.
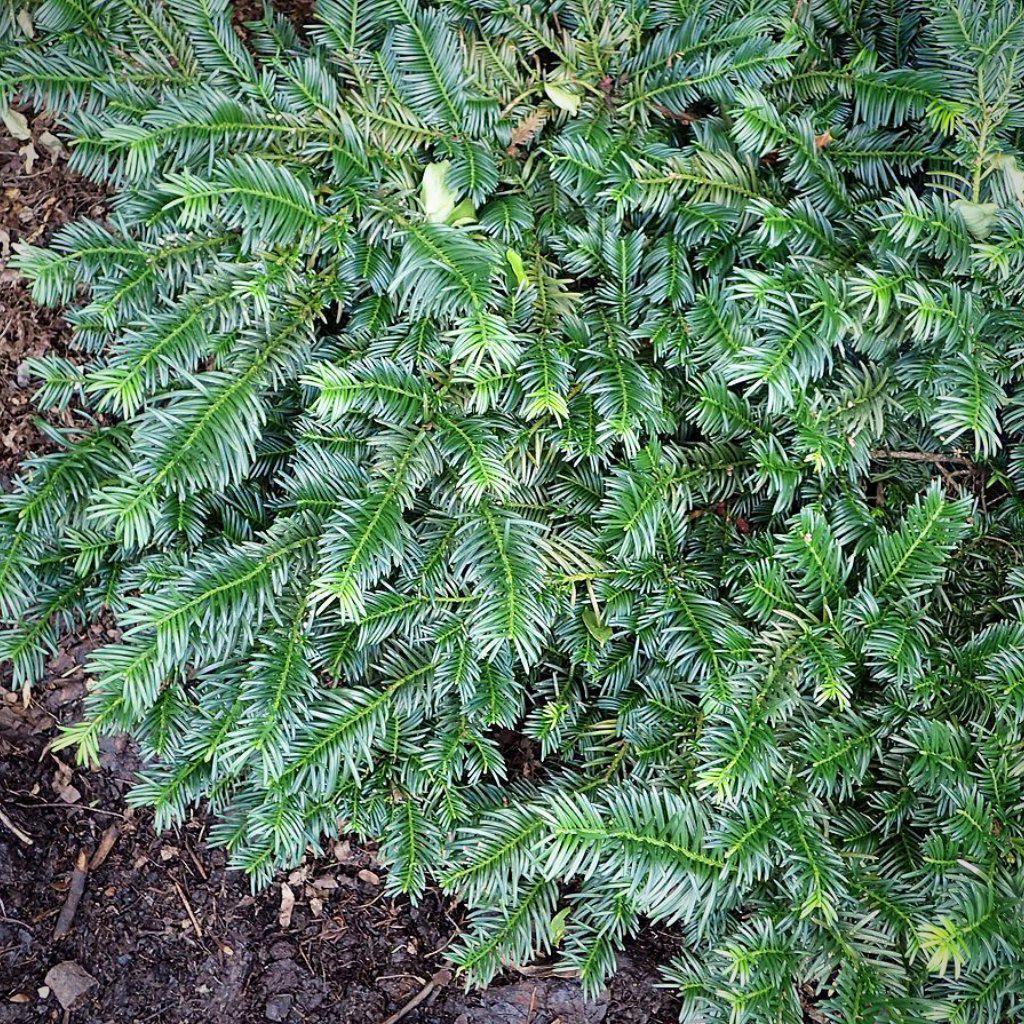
<box><xmin>0</xmin><ymin>94</ymin><xmax>679</xmax><ymax>1024</ymax></box>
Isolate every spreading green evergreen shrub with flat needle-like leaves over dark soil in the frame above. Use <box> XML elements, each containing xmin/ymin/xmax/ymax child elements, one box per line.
<box><xmin>0</xmin><ymin>0</ymin><xmax>1024</xmax><ymax>1024</ymax></box>
